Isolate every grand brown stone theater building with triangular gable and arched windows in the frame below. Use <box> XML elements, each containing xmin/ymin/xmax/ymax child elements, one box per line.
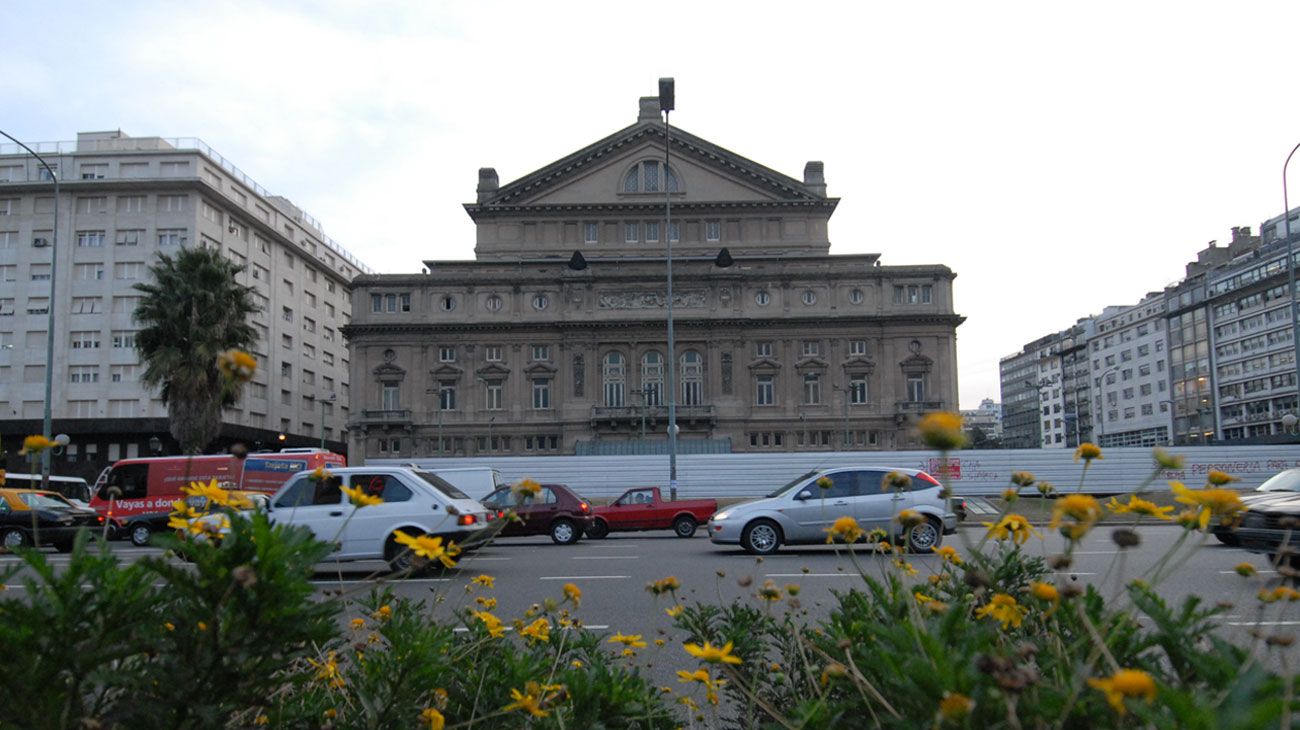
<box><xmin>345</xmin><ymin>97</ymin><xmax>963</xmax><ymax>460</ymax></box>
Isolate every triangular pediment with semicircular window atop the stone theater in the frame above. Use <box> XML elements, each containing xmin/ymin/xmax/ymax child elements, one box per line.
<box><xmin>467</xmin><ymin>122</ymin><xmax>828</xmax><ymax>214</ymax></box>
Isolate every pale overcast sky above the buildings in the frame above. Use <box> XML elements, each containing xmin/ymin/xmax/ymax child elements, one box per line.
<box><xmin>0</xmin><ymin>0</ymin><xmax>1300</xmax><ymax>408</ymax></box>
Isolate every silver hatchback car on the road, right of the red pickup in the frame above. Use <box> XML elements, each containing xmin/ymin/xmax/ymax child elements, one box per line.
<box><xmin>709</xmin><ymin>466</ymin><xmax>957</xmax><ymax>555</ymax></box>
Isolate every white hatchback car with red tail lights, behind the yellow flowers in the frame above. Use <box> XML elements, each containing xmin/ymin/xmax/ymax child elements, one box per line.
<box><xmin>270</xmin><ymin>466</ymin><xmax>491</xmax><ymax>570</ymax></box>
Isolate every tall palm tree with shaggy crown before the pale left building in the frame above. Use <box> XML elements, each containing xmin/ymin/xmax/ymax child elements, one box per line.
<box><xmin>135</xmin><ymin>248</ymin><xmax>257</xmax><ymax>453</ymax></box>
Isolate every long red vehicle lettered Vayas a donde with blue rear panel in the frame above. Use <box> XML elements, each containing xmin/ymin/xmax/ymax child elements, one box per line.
<box><xmin>90</xmin><ymin>448</ymin><xmax>347</xmax><ymax>527</ymax></box>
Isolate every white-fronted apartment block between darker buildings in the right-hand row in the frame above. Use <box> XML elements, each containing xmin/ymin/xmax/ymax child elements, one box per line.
<box><xmin>1088</xmin><ymin>292</ymin><xmax>1173</xmax><ymax>447</ymax></box>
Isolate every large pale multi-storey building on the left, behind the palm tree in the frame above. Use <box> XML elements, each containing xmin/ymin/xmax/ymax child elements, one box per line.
<box><xmin>0</xmin><ymin>131</ymin><xmax>369</xmax><ymax>477</ymax></box>
